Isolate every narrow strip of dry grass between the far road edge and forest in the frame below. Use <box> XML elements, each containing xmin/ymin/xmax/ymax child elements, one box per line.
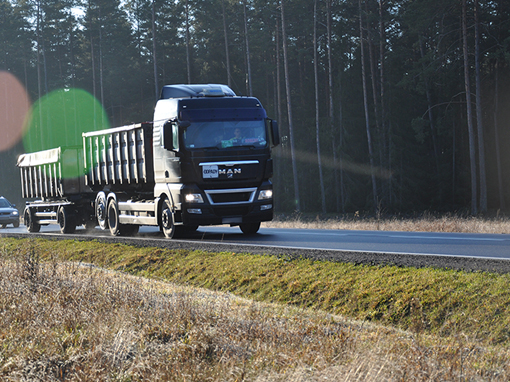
<box><xmin>263</xmin><ymin>213</ymin><xmax>510</xmax><ymax>234</ymax></box>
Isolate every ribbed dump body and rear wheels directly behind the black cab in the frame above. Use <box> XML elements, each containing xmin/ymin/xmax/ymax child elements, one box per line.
<box><xmin>83</xmin><ymin>123</ymin><xmax>158</xmax><ymax>235</ymax></box>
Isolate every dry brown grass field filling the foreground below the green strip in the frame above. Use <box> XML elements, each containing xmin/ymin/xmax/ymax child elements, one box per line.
<box><xmin>0</xmin><ymin>246</ymin><xmax>510</xmax><ymax>381</ymax></box>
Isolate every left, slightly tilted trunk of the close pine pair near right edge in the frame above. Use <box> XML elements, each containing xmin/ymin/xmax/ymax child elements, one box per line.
<box><xmin>462</xmin><ymin>0</ymin><xmax>478</xmax><ymax>215</ymax></box>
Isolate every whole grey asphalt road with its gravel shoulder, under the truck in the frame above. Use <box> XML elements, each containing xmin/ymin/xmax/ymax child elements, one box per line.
<box><xmin>0</xmin><ymin>226</ymin><xmax>510</xmax><ymax>273</ymax></box>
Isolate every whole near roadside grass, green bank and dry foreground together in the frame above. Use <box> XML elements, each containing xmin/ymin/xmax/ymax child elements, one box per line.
<box><xmin>0</xmin><ymin>238</ymin><xmax>510</xmax><ymax>381</ymax></box>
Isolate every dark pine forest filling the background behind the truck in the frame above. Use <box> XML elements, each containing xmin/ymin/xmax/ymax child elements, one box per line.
<box><xmin>0</xmin><ymin>0</ymin><xmax>510</xmax><ymax>215</ymax></box>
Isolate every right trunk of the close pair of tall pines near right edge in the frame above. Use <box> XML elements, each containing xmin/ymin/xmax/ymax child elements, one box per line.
<box><xmin>474</xmin><ymin>0</ymin><xmax>487</xmax><ymax>213</ymax></box>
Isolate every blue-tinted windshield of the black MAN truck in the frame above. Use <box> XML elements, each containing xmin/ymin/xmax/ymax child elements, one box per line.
<box><xmin>184</xmin><ymin>120</ymin><xmax>267</xmax><ymax>149</ymax></box>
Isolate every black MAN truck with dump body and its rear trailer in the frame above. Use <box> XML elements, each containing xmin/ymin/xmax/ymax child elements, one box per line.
<box><xmin>17</xmin><ymin>84</ymin><xmax>280</xmax><ymax>238</ymax></box>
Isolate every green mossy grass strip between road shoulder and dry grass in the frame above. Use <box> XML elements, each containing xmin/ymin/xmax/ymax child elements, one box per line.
<box><xmin>0</xmin><ymin>238</ymin><xmax>510</xmax><ymax>345</ymax></box>
